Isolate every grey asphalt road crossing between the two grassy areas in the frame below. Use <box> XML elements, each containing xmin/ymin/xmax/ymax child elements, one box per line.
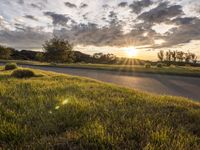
<box><xmin>12</xmin><ymin>65</ymin><xmax>200</xmax><ymax>101</ymax></box>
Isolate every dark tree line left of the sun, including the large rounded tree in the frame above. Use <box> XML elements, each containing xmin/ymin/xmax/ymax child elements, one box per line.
<box><xmin>0</xmin><ymin>37</ymin><xmax>145</xmax><ymax>65</ymax></box>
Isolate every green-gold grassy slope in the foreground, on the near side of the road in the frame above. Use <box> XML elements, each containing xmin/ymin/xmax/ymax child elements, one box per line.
<box><xmin>0</xmin><ymin>69</ymin><xmax>200</xmax><ymax>150</ymax></box>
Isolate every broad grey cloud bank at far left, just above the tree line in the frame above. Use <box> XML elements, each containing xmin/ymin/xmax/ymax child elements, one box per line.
<box><xmin>0</xmin><ymin>26</ymin><xmax>52</xmax><ymax>49</ymax></box>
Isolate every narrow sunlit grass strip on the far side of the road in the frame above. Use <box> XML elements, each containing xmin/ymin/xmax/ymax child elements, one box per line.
<box><xmin>0</xmin><ymin>60</ymin><xmax>200</xmax><ymax>77</ymax></box>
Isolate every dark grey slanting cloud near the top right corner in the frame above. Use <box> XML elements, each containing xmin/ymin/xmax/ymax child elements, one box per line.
<box><xmin>138</xmin><ymin>2</ymin><xmax>184</xmax><ymax>23</ymax></box>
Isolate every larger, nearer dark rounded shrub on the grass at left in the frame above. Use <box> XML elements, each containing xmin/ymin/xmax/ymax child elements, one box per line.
<box><xmin>11</xmin><ymin>69</ymin><xmax>35</xmax><ymax>78</ymax></box>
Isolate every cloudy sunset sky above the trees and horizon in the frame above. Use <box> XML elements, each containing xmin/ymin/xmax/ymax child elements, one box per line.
<box><xmin>0</xmin><ymin>0</ymin><xmax>200</xmax><ymax>60</ymax></box>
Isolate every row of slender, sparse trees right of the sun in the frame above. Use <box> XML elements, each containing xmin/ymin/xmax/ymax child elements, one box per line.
<box><xmin>157</xmin><ymin>50</ymin><xmax>197</xmax><ymax>64</ymax></box>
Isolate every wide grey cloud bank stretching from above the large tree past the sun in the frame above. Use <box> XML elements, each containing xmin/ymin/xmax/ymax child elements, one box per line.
<box><xmin>54</xmin><ymin>20</ymin><xmax>156</xmax><ymax>46</ymax></box>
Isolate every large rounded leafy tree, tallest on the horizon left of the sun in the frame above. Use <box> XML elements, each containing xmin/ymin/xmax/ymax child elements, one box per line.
<box><xmin>43</xmin><ymin>37</ymin><xmax>74</xmax><ymax>62</ymax></box>
